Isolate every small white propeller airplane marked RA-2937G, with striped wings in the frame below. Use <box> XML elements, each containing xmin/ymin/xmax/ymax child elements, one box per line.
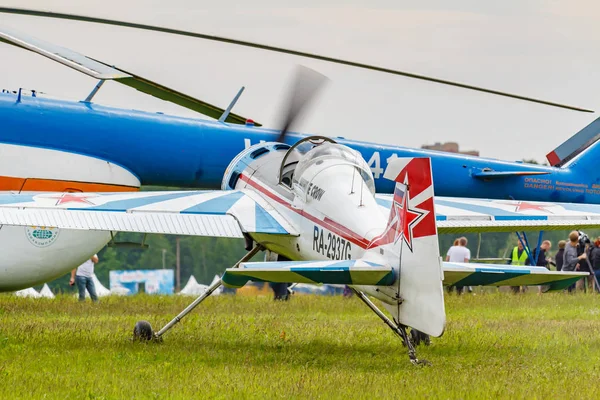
<box><xmin>0</xmin><ymin>137</ymin><xmax>600</xmax><ymax>363</ymax></box>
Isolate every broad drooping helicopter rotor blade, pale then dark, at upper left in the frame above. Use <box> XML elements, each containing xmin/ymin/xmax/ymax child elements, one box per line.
<box><xmin>0</xmin><ymin>26</ymin><xmax>260</xmax><ymax>126</ymax></box>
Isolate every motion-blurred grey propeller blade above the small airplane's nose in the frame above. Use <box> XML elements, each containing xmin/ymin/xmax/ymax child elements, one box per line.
<box><xmin>276</xmin><ymin>65</ymin><xmax>328</xmax><ymax>142</ymax></box>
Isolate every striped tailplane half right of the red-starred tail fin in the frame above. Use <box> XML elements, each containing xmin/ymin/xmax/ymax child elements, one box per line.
<box><xmin>443</xmin><ymin>262</ymin><xmax>589</xmax><ymax>290</ymax></box>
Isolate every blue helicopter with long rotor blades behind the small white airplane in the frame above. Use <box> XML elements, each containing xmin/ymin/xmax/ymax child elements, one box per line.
<box><xmin>0</xmin><ymin>7</ymin><xmax>600</xmax><ymax>207</ymax></box>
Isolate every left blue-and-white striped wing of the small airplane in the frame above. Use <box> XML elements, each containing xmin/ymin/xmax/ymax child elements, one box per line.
<box><xmin>0</xmin><ymin>190</ymin><xmax>297</xmax><ymax>238</ymax></box>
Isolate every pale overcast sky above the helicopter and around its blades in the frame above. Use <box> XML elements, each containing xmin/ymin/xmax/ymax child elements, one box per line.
<box><xmin>0</xmin><ymin>0</ymin><xmax>600</xmax><ymax>161</ymax></box>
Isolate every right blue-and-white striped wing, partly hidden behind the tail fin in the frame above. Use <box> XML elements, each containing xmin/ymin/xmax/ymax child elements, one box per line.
<box><xmin>376</xmin><ymin>194</ymin><xmax>600</xmax><ymax>233</ymax></box>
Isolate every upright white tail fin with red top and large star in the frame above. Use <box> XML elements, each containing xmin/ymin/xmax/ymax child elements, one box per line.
<box><xmin>374</xmin><ymin>158</ymin><xmax>446</xmax><ymax>337</ymax></box>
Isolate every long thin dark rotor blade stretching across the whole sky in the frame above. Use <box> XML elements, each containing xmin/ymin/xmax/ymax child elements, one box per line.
<box><xmin>0</xmin><ymin>7</ymin><xmax>594</xmax><ymax>113</ymax></box>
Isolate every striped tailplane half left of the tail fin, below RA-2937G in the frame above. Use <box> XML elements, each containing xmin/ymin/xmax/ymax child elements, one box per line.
<box><xmin>222</xmin><ymin>260</ymin><xmax>396</xmax><ymax>287</ymax></box>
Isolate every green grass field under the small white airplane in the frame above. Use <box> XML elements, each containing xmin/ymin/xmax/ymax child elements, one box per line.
<box><xmin>0</xmin><ymin>293</ymin><xmax>600</xmax><ymax>399</ymax></box>
